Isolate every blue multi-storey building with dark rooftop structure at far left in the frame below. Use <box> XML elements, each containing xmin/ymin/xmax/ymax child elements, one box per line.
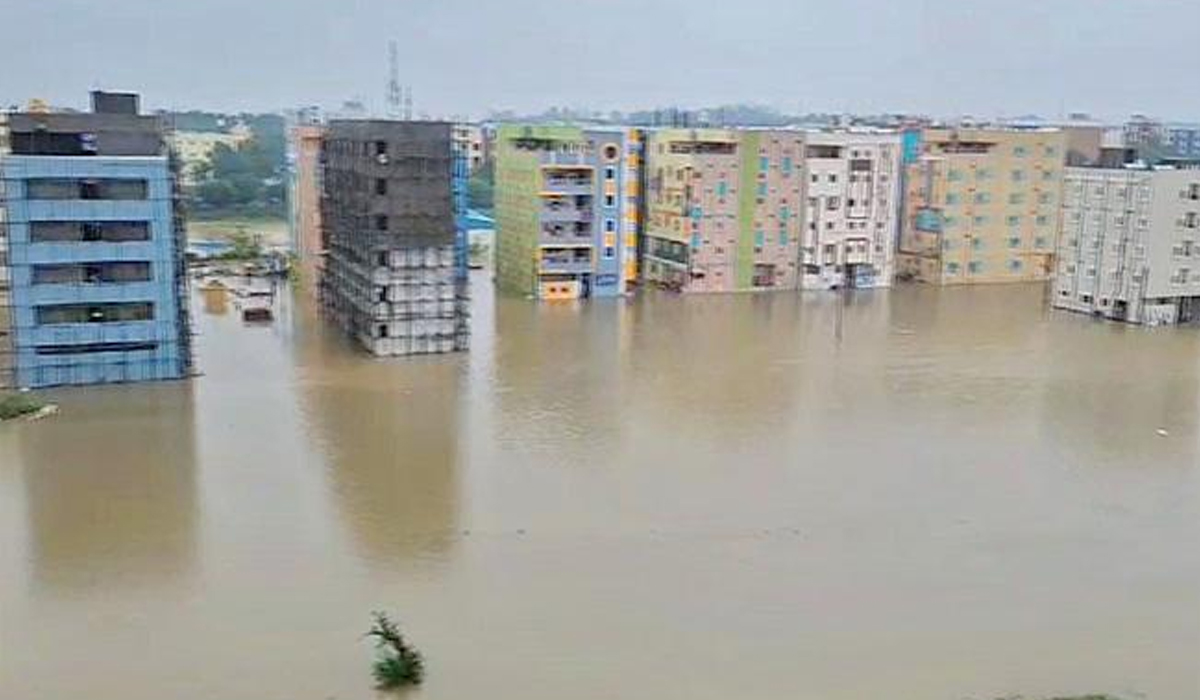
<box><xmin>0</xmin><ymin>92</ymin><xmax>192</xmax><ymax>387</ymax></box>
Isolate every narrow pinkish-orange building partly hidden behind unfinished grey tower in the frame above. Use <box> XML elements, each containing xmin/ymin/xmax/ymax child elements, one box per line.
<box><xmin>288</xmin><ymin>124</ymin><xmax>325</xmax><ymax>294</ymax></box>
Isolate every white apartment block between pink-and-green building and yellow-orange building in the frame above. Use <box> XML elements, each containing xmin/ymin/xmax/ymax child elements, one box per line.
<box><xmin>800</xmin><ymin>132</ymin><xmax>901</xmax><ymax>289</ymax></box>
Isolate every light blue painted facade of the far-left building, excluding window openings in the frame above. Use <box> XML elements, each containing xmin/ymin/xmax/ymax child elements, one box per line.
<box><xmin>0</xmin><ymin>156</ymin><xmax>187</xmax><ymax>387</ymax></box>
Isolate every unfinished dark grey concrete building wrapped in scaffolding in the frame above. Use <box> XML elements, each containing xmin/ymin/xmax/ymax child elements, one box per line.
<box><xmin>320</xmin><ymin>120</ymin><xmax>469</xmax><ymax>355</ymax></box>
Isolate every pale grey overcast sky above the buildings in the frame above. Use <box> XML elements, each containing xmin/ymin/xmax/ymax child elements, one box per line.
<box><xmin>0</xmin><ymin>0</ymin><xmax>1200</xmax><ymax>121</ymax></box>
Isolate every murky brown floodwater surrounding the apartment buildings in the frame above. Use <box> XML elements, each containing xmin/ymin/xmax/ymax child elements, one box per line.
<box><xmin>0</xmin><ymin>273</ymin><xmax>1200</xmax><ymax>700</ymax></box>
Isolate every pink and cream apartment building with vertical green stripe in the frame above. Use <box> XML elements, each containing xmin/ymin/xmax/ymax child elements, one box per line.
<box><xmin>642</xmin><ymin>128</ymin><xmax>805</xmax><ymax>292</ymax></box>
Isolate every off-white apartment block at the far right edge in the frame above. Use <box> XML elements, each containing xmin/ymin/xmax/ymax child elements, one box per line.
<box><xmin>1054</xmin><ymin>168</ymin><xmax>1200</xmax><ymax>325</ymax></box>
